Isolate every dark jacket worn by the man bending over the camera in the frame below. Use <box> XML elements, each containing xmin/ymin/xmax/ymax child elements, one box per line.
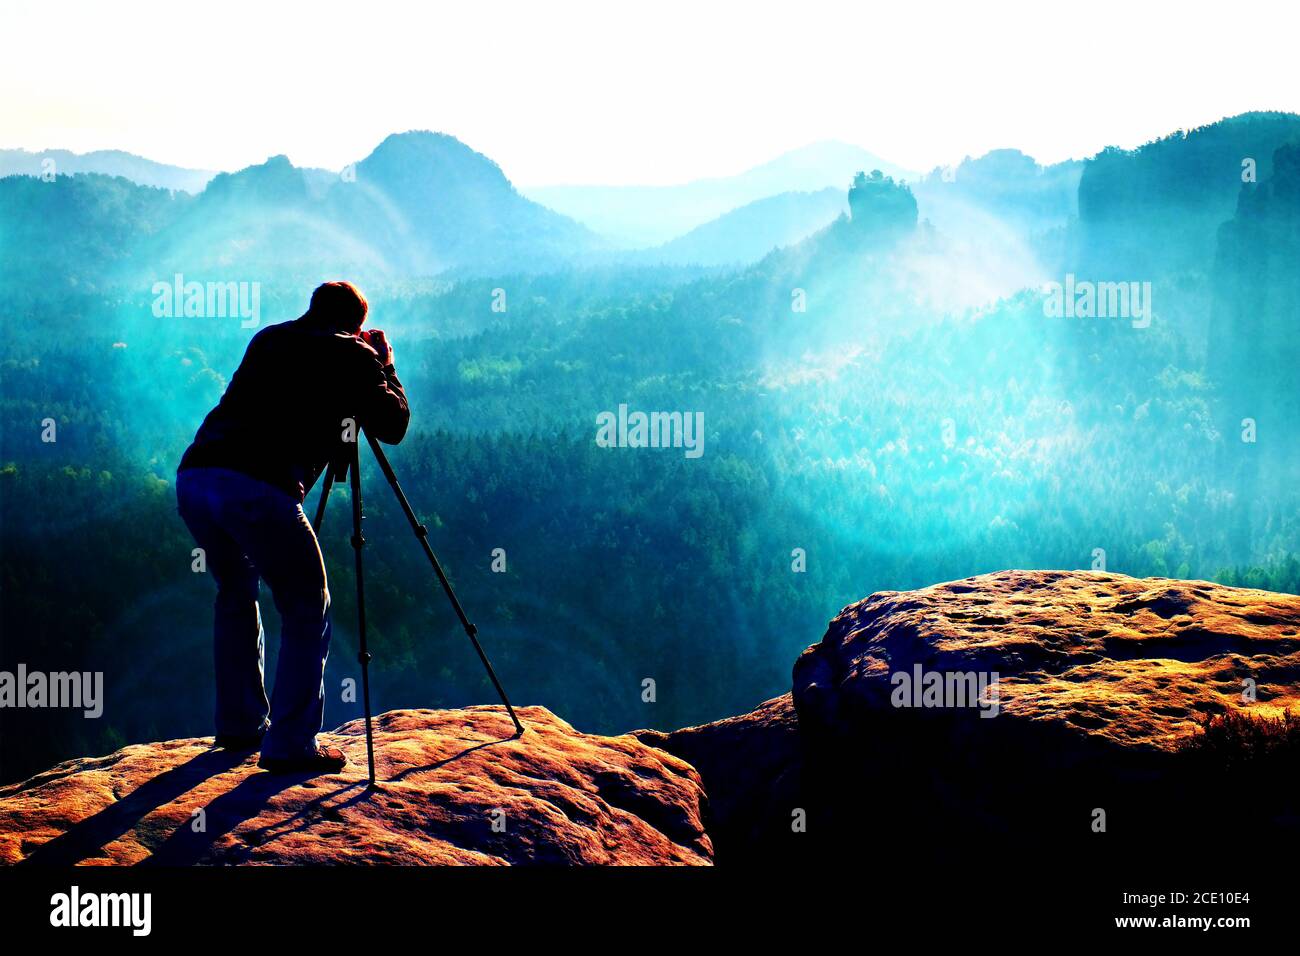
<box><xmin>178</xmin><ymin>316</ymin><xmax>411</xmax><ymax>501</ymax></box>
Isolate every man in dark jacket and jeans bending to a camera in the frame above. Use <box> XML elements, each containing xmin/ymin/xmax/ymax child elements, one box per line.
<box><xmin>176</xmin><ymin>282</ymin><xmax>411</xmax><ymax>773</ymax></box>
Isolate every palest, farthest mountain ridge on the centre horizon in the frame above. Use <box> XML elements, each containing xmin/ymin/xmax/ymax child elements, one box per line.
<box><xmin>524</xmin><ymin>142</ymin><xmax>913</xmax><ymax>247</ymax></box>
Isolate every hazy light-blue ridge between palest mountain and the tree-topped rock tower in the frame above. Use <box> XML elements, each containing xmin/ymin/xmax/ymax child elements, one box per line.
<box><xmin>636</xmin><ymin>187</ymin><xmax>849</xmax><ymax>265</ymax></box>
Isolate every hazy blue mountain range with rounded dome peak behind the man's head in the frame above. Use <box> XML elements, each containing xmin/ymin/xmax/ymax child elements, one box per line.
<box><xmin>0</xmin><ymin>133</ymin><xmax>605</xmax><ymax>285</ymax></box>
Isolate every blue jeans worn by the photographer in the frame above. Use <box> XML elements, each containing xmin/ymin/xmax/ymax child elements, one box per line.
<box><xmin>176</xmin><ymin>468</ymin><xmax>330</xmax><ymax>758</ymax></box>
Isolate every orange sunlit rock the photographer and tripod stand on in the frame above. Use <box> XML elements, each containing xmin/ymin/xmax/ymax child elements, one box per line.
<box><xmin>0</xmin><ymin>706</ymin><xmax>712</xmax><ymax>865</ymax></box>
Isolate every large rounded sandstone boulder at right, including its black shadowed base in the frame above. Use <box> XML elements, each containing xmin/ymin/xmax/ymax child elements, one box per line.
<box><xmin>793</xmin><ymin>571</ymin><xmax>1300</xmax><ymax>866</ymax></box>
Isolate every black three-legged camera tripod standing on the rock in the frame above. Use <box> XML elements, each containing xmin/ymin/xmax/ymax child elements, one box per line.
<box><xmin>312</xmin><ymin>433</ymin><xmax>524</xmax><ymax>787</ymax></box>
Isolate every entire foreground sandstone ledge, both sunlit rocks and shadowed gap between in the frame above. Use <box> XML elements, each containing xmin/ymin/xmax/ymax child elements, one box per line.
<box><xmin>0</xmin><ymin>571</ymin><xmax>1300</xmax><ymax>878</ymax></box>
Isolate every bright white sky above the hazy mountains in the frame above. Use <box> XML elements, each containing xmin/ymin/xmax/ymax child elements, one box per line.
<box><xmin>0</xmin><ymin>0</ymin><xmax>1300</xmax><ymax>185</ymax></box>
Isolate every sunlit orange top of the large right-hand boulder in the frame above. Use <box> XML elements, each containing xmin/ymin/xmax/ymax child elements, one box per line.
<box><xmin>794</xmin><ymin>571</ymin><xmax>1300</xmax><ymax>750</ymax></box>
